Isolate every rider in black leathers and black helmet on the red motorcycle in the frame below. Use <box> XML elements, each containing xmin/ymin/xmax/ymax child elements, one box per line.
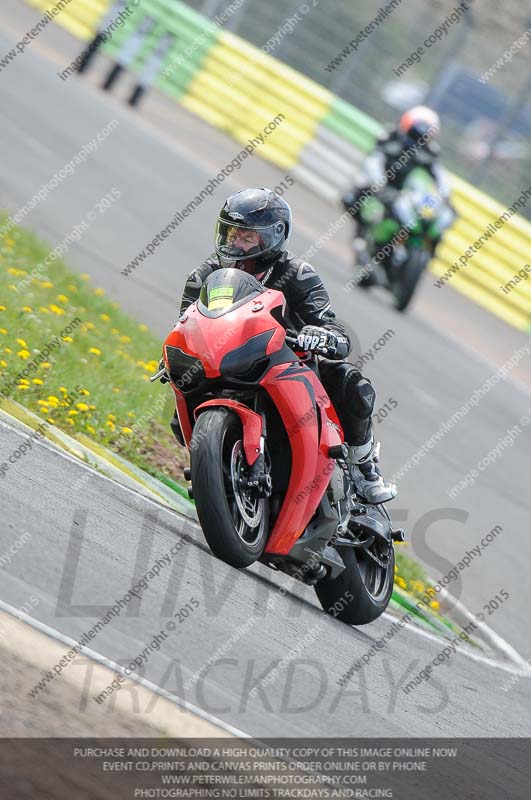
<box><xmin>171</xmin><ymin>188</ymin><xmax>397</xmax><ymax>503</ymax></box>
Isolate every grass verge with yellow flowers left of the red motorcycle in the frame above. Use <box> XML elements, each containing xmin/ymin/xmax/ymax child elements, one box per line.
<box><xmin>0</xmin><ymin>215</ymin><xmax>186</xmax><ymax>478</ymax></box>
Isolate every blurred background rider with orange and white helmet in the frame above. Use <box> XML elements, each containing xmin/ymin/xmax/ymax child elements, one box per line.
<box><xmin>343</xmin><ymin>106</ymin><xmax>455</xmax><ymax>251</ymax></box>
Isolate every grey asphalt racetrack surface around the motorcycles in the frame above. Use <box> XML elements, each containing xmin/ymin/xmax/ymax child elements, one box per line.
<box><xmin>0</xmin><ymin>0</ymin><xmax>531</xmax><ymax>736</ymax></box>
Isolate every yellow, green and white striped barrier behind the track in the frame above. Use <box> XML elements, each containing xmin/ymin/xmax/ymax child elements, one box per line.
<box><xmin>21</xmin><ymin>0</ymin><xmax>531</xmax><ymax>332</ymax></box>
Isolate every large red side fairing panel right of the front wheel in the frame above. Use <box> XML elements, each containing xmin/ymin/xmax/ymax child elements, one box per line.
<box><xmin>260</xmin><ymin>363</ymin><xmax>343</xmax><ymax>555</ymax></box>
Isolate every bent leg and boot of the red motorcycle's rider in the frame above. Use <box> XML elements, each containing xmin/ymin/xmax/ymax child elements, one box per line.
<box><xmin>319</xmin><ymin>359</ymin><xmax>397</xmax><ymax>503</ymax></box>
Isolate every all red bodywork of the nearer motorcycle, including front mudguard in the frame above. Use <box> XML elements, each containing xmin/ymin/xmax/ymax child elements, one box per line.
<box><xmin>164</xmin><ymin>289</ymin><xmax>343</xmax><ymax>555</ymax></box>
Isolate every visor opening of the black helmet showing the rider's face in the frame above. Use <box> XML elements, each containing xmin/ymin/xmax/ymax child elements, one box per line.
<box><xmin>216</xmin><ymin>218</ymin><xmax>284</xmax><ymax>261</ymax></box>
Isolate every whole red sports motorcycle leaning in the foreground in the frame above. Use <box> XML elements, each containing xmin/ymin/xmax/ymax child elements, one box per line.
<box><xmin>154</xmin><ymin>269</ymin><xmax>403</xmax><ymax>625</ymax></box>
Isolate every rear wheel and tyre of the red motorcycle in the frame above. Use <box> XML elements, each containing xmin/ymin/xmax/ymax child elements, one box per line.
<box><xmin>315</xmin><ymin>545</ymin><xmax>395</xmax><ymax>625</ymax></box>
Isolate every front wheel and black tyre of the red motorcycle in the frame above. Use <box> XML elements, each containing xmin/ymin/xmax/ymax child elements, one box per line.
<box><xmin>190</xmin><ymin>408</ymin><xmax>269</xmax><ymax>568</ymax></box>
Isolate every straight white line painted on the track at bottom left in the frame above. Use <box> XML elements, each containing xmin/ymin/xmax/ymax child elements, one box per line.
<box><xmin>0</xmin><ymin>600</ymin><xmax>252</xmax><ymax>739</ymax></box>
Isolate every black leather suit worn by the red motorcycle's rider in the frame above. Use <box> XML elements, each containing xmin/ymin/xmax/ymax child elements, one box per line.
<box><xmin>181</xmin><ymin>253</ymin><xmax>376</xmax><ymax>445</ymax></box>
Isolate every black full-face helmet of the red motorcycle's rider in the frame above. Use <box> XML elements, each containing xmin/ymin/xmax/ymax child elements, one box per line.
<box><xmin>216</xmin><ymin>189</ymin><xmax>291</xmax><ymax>274</ymax></box>
